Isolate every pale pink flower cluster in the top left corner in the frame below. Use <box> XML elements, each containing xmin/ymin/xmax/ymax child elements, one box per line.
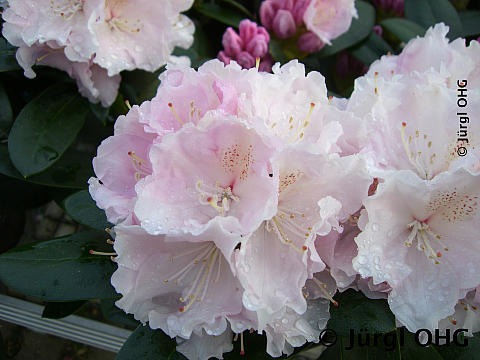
<box><xmin>3</xmin><ymin>0</ymin><xmax>194</xmax><ymax>106</ymax></box>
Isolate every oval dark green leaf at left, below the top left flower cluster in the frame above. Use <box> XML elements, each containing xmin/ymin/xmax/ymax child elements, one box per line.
<box><xmin>8</xmin><ymin>83</ymin><xmax>88</xmax><ymax>177</ymax></box>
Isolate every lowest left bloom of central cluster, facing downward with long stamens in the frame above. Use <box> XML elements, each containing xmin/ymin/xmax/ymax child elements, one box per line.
<box><xmin>112</xmin><ymin>223</ymin><xmax>242</xmax><ymax>339</ymax></box>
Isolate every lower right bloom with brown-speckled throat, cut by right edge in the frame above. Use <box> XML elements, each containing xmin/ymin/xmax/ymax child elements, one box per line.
<box><xmin>353</xmin><ymin>169</ymin><xmax>480</xmax><ymax>331</ymax></box>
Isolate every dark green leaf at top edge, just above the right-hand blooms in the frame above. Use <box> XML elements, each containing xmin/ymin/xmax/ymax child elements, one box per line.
<box><xmin>405</xmin><ymin>0</ymin><xmax>463</xmax><ymax>40</ymax></box>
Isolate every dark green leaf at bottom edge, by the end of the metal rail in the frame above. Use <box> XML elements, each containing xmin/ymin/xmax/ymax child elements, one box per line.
<box><xmin>115</xmin><ymin>325</ymin><xmax>176</xmax><ymax>360</ymax></box>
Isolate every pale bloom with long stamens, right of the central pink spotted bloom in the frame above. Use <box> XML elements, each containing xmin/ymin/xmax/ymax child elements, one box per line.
<box><xmin>237</xmin><ymin>149</ymin><xmax>371</xmax><ymax>314</ymax></box>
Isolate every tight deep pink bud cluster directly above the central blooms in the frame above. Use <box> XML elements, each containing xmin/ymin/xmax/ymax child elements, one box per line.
<box><xmin>218</xmin><ymin>19</ymin><xmax>273</xmax><ymax>71</ymax></box>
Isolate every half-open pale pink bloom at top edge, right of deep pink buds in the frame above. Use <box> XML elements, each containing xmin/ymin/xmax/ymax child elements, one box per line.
<box><xmin>303</xmin><ymin>0</ymin><xmax>358</xmax><ymax>45</ymax></box>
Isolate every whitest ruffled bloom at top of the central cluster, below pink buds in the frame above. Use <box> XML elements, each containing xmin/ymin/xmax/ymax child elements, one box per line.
<box><xmin>239</xmin><ymin>60</ymin><xmax>344</xmax><ymax>154</ymax></box>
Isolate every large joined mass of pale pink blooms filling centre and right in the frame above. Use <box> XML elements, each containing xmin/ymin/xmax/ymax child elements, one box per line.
<box><xmin>89</xmin><ymin>25</ymin><xmax>480</xmax><ymax>359</ymax></box>
